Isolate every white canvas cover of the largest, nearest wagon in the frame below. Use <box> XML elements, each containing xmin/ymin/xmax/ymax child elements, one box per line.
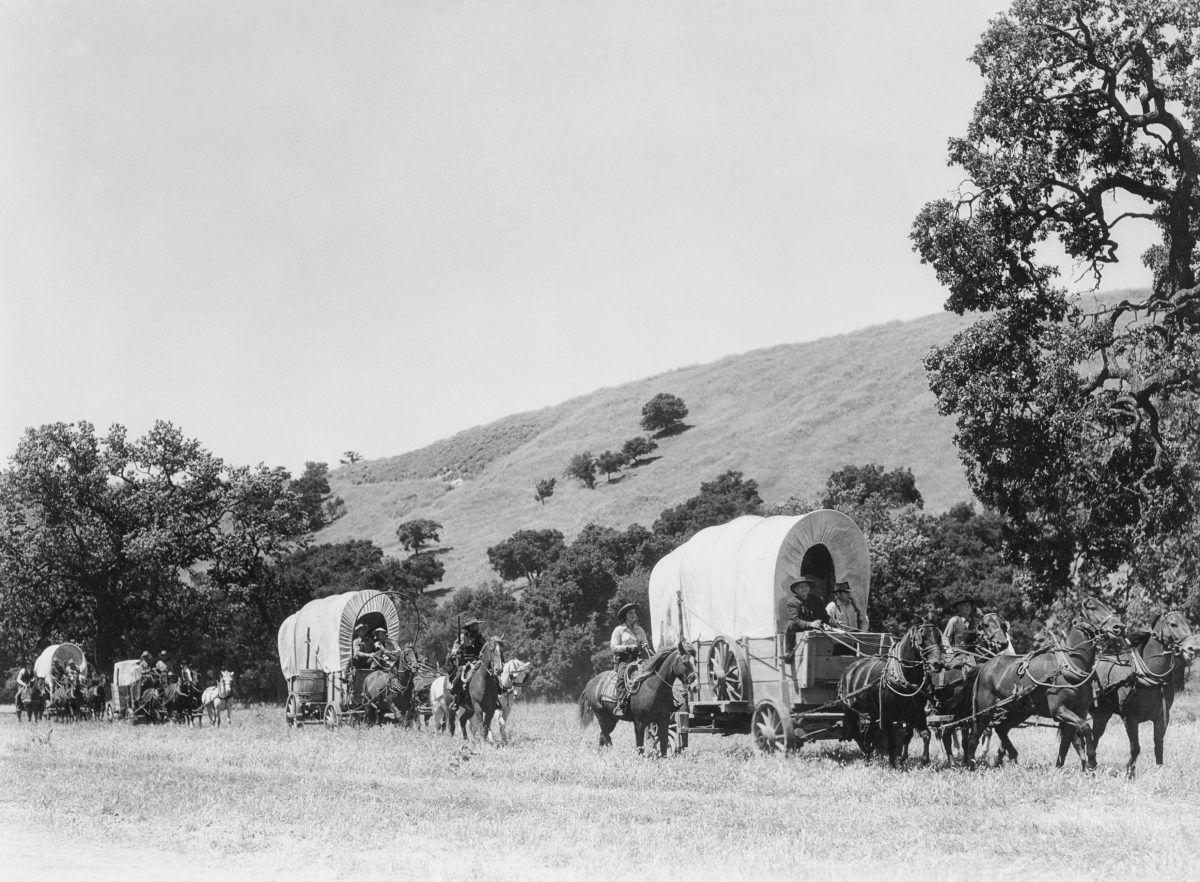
<box><xmin>649</xmin><ymin>509</ymin><xmax>871</xmax><ymax>648</ymax></box>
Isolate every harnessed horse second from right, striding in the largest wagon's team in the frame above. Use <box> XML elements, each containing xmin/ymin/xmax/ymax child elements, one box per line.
<box><xmin>964</xmin><ymin>596</ymin><xmax>1124</xmax><ymax>772</ymax></box>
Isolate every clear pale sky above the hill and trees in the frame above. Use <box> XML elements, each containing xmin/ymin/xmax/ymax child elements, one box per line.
<box><xmin>0</xmin><ymin>0</ymin><xmax>1145</xmax><ymax>472</ymax></box>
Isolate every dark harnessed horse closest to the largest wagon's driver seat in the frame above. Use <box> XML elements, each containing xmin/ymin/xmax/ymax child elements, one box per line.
<box><xmin>838</xmin><ymin>622</ymin><xmax>946</xmax><ymax>768</ymax></box>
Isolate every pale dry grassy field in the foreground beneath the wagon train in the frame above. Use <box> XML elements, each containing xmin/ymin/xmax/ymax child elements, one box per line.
<box><xmin>0</xmin><ymin>696</ymin><xmax>1200</xmax><ymax>882</ymax></box>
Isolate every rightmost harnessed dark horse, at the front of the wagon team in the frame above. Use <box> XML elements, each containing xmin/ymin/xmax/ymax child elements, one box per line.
<box><xmin>1092</xmin><ymin>611</ymin><xmax>1192</xmax><ymax>778</ymax></box>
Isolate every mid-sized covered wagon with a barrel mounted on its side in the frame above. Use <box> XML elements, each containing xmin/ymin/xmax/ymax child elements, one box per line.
<box><xmin>278</xmin><ymin>590</ymin><xmax>401</xmax><ymax>726</ymax></box>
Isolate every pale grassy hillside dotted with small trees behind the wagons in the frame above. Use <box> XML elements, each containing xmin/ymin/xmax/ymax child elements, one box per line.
<box><xmin>317</xmin><ymin>313</ymin><xmax>984</xmax><ymax>586</ymax></box>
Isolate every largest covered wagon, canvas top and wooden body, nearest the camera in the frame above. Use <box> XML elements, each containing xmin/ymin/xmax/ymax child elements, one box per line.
<box><xmin>649</xmin><ymin>510</ymin><xmax>892</xmax><ymax>751</ymax></box>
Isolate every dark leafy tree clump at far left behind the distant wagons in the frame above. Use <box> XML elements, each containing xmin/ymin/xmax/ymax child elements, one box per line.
<box><xmin>0</xmin><ymin>422</ymin><xmax>308</xmax><ymax>664</ymax></box>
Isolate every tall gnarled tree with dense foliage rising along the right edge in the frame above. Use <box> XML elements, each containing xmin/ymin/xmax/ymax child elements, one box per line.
<box><xmin>912</xmin><ymin>0</ymin><xmax>1200</xmax><ymax>601</ymax></box>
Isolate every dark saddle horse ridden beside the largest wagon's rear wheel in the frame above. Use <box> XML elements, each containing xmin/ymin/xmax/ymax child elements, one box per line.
<box><xmin>580</xmin><ymin>641</ymin><xmax>696</xmax><ymax>756</ymax></box>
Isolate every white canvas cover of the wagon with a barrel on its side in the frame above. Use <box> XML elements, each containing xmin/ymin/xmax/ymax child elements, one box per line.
<box><xmin>280</xmin><ymin>590</ymin><xmax>400</xmax><ymax>680</ymax></box>
